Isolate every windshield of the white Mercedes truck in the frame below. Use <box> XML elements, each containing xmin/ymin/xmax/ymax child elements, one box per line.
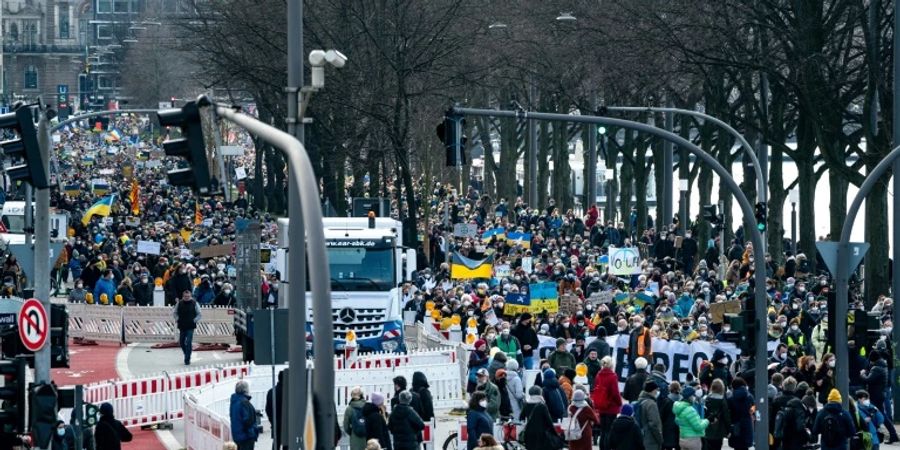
<box><xmin>327</xmin><ymin>247</ymin><xmax>394</xmax><ymax>291</ymax></box>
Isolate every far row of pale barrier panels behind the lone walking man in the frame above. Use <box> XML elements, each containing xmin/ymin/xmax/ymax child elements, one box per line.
<box><xmin>66</xmin><ymin>303</ymin><xmax>235</xmax><ymax>344</ymax></box>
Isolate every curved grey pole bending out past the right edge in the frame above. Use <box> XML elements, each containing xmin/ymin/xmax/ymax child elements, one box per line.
<box><xmin>828</xmin><ymin>146</ymin><xmax>900</xmax><ymax>408</ymax></box>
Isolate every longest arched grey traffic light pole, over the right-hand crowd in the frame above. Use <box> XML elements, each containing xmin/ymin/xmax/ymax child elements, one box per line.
<box><xmin>450</xmin><ymin>104</ymin><xmax>769</xmax><ymax>450</ymax></box>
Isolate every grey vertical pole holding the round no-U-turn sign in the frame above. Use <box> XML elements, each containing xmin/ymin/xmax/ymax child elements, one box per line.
<box><xmin>32</xmin><ymin>111</ymin><xmax>51</xmax><ymax>383</ymax></box>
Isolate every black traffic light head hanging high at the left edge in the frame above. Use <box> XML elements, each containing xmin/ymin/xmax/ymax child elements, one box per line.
<box><xmin>0</xmin><ymin>105</ymin><xmax>50</xmax><ymax>189</ymax></box>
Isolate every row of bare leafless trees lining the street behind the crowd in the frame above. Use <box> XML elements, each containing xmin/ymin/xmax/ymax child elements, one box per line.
<box><xmin>123</xmin><ymin>0</ymin><xmax>893</xmax><ymax>297</ymax></box>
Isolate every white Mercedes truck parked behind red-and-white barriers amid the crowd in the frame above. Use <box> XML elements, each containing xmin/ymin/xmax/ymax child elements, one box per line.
<box><xmin>236</xmin><ymin>217</ymin><xmax>416</xmax><ymax>352</ymax></box>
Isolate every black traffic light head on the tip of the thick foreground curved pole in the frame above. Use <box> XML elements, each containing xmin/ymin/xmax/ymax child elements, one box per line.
<box><xmin>156</xmin><ymin>100</ymin><xmax>211</xmax><ymax>194</ymax></box>
